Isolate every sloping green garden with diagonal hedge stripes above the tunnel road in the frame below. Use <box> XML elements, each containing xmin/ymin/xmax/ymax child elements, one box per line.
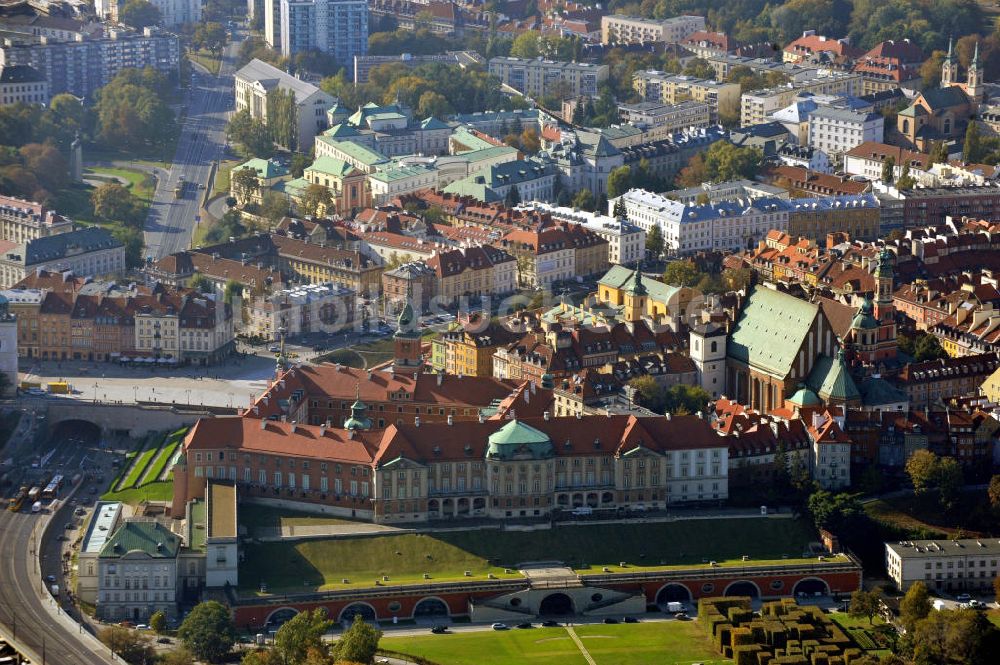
<box><xmin>101</xmin><ymin>427</ymin><xmax>187</xmax><ymax>504</ymax></box>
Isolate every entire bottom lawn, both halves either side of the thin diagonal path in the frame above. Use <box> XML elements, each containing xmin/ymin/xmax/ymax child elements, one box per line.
<box><xmin>379</xmin><ymin>621</ymin><xmax>732</xmax><ymax>665</ymax></box>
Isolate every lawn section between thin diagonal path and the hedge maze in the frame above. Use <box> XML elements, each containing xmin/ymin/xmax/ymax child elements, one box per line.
<box><xmin>574</xmin><ymin>621</ymin><xmax>731</xmax><ymax>665</ymax></box>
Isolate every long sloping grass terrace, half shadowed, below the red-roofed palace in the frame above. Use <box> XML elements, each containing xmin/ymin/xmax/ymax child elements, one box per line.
<box><xmin>240</xmin><ymin>519</ymin><xmax>815</xmax><ymax>591</ymax></box>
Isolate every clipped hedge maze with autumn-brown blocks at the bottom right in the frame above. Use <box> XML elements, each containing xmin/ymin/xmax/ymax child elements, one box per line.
<box><xmin>698</xmin><ymin>596</ymin><xmax>864</xmax><ymax>665</ymax></box>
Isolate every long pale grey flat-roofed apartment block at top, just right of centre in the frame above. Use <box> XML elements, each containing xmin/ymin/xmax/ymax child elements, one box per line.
<box><xmin>490</xmin><ymin>57</ymin><xmax>609</xmax><ymax>97</ymax></box>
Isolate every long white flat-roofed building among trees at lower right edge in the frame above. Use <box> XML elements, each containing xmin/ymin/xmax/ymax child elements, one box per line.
<box><xmin>885</xmin><ymin>538</ymin><xmax>1000</xmax><ymax>597</ymax></box>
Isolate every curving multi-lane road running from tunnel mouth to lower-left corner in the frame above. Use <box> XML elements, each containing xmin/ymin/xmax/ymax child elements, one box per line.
<box><xmin>0</xmin><ymin>422</ymin><xmax>114</xmax><ymax>665</ymax></box>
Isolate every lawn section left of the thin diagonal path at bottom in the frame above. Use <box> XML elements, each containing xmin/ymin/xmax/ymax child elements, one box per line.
<box><xmin>379</xmin><ymin>628</ymin><xmax>587</xmax><ymax>665</ymax></box>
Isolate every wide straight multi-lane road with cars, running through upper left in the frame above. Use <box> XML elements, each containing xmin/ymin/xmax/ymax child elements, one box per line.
<box><xmin>145</xmin><ymin>35</ymin><xmax>239</xmax><ymax>260</ymax></box>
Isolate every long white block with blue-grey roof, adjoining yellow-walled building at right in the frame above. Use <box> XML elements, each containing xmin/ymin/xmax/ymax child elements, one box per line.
<box><xmin>608</xmin><ymin>189</ymin><xmax>788</xmax><ymax>256</ymax></box>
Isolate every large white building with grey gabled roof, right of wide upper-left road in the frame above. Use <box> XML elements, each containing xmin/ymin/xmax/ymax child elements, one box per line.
<box><xmin>233</xmin><ymin>58</ymin><xmax>336</xmax><ymax>150</ymax></box>
